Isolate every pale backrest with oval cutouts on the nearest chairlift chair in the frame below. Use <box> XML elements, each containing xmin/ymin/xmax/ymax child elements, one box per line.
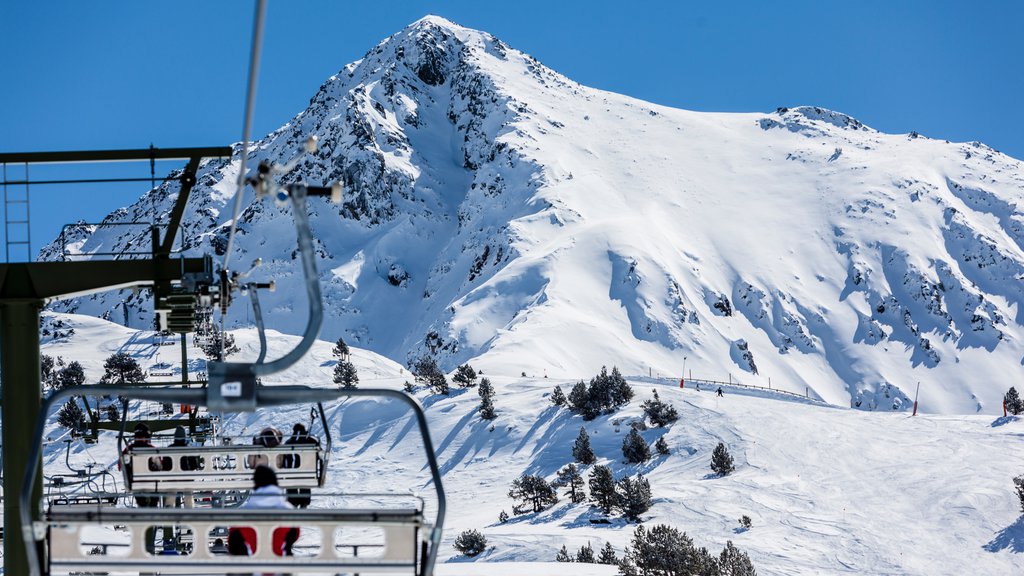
<box><xmin>43</xmin><ymin>506</ymin><xmax>430</xmax><ymax>574</ymax></box>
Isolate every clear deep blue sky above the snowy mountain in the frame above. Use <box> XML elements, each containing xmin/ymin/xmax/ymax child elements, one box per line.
<box><xmin>0</xmin><ymin>0</ymin><xmax>1024</xmax><ymax>259</ymax></box>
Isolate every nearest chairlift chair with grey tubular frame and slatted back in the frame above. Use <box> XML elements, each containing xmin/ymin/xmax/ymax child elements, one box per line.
<box><xmin>22</xmin><ymin>385</ymin><xmax>445</xmax><ymax>576</ymax></box>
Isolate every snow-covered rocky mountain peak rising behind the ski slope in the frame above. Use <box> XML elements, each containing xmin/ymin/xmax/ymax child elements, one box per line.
<box><xmin>42</xmin><ymin>16</ymin><xmax>1024</xmax><ymax>414</ymax></box>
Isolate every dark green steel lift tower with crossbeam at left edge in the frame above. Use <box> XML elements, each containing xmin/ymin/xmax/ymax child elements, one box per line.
<box><xmin>0</xmin><ymin>147</ymin><xmax>231</xmax><ymax>574</ymax></box>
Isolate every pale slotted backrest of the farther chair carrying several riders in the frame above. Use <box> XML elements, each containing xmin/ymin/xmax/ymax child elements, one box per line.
<box><xmin>121</xmin><ymin>444</ymin><xmax>327</xmax><ymax>492</ymax></box>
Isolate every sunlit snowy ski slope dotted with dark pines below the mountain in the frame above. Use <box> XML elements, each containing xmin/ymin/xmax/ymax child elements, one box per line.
<box><xmin>14</xmin><ymin>315</ymin><xmax>1024</xmax><ymax>576</ymax></box>
